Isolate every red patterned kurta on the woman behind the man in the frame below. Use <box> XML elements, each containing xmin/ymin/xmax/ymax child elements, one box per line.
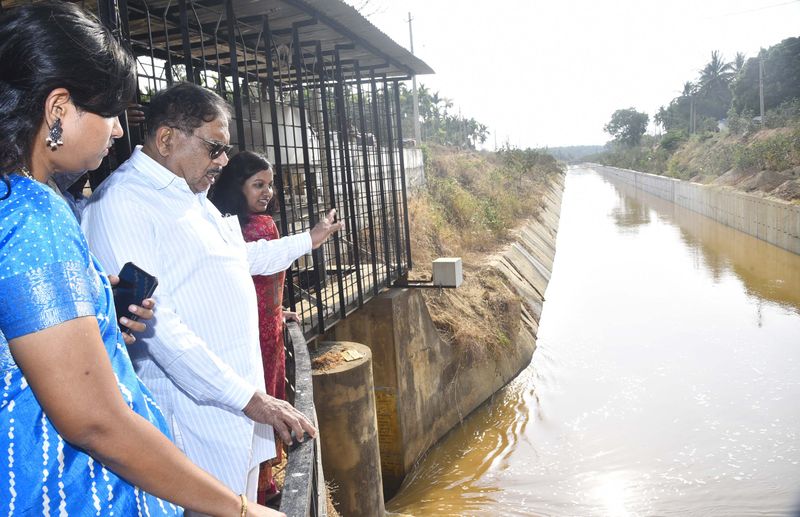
<box><xmin>242</xmin><ymin>215</ymin><xmax>286</xmax><ymax>400</ymax></box>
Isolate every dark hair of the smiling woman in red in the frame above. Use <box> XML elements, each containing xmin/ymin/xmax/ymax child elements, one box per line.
<box><xmin>208</xmin><ymin>151</ymin><xmax>275</xmax><ymax>228</ymax></box>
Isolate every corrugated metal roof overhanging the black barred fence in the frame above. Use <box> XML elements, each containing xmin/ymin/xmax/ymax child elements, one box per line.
<box><xmin>0</xmin><ymin>0</ymin><xmax>434</xmax><ymax>77</ymax></box>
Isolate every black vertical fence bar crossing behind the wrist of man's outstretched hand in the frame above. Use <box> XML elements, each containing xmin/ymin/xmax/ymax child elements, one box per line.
<box><xmin>294</xmin><ymin>24</ymin><xmax>325</xmax><ymax>334</ymax></box>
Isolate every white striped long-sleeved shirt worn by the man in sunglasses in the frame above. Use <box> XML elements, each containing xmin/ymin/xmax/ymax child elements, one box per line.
<box><xmin>82</xmin><ymin>147</ymin><xmax>311</xmax><ymax>493</ymax></box>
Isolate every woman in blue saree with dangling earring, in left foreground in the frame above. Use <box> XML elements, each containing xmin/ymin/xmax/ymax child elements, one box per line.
<box><xmin>0</xmin><ymin>2</ymin><xmax>278</xmax><ymax>517</ymax></box>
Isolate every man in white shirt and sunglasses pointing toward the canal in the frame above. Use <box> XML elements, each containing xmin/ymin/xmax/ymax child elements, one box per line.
<box><xmin>82</xmin><ymin>83</ymin><xmax>342</xmax><ymax>499</ymax></box>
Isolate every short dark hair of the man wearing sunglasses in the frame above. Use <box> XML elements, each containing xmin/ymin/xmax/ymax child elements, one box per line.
<box><xmin>145</xmin><ymin>83</ymin><xmax>230</xmax><ymax>137</ymax></box>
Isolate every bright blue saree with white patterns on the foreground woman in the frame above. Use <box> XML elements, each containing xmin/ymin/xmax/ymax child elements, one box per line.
<box><xmin>0</xmin><ymin>174</ymin><xmax>182</xmax><ymax>517</ymax></box>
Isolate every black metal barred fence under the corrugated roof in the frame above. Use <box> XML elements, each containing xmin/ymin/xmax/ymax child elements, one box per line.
<box><xmin>110</xmin><ymin>0</ymin><xmax>411</xmax><ymax>339</ymax></box>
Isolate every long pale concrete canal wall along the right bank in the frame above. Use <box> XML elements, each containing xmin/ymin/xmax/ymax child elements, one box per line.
<box><xmin>589</xmin><ymin>164</ymin><xmax>800</xmax><ymax>254</ymax></box>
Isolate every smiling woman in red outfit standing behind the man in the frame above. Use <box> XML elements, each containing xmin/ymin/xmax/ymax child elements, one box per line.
<box><xmin>209</xmin><ymin>151</ymin><xmax>298</xmax><ymax>499</ymax></box>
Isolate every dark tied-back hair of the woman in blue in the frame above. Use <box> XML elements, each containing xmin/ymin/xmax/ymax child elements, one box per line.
<box><xmin>0</xmin><ymin>2</ymin><xmax>136</xmax><ymax>182</ymax></box>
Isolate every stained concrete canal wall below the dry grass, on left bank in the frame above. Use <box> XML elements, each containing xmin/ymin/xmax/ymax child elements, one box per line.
<box><xmin>328</xmin><ymin>176</ymin><xmax>564</xmax><ymax>499</ymax></box>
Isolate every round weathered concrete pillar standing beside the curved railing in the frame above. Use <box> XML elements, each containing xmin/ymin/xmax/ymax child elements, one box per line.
<box><xmin>312</xmin><ymin>341</ymin><xmax>385</xmax><ymax>517</ymax></box>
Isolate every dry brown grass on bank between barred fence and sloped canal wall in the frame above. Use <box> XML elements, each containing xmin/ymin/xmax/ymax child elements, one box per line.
<box><xmin>409</xmin><ymin>147</ymin><xmax>561</xmax><ymax>357</ymax></box>
